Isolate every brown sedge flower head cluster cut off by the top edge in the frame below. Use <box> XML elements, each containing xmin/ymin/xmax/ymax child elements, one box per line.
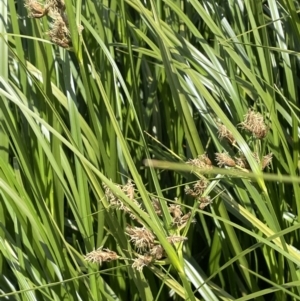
<box><xmin>25</xmin><ymin>0</ymin><xmax>78</xmax><ymax>48</ymax></box>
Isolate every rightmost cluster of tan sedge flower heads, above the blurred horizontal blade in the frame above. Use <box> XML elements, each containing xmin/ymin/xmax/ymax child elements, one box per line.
<box><xmin>216</xmin><ymin>109</ymin><xmax>273</xmax><ymax>170</ymax></box>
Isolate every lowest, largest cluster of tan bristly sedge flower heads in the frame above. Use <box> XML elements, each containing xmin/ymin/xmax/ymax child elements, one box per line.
<box><xmin>85</xmin><ymin>180</ymin><xmax>192</xmax><ymax>271</ymax></box>
